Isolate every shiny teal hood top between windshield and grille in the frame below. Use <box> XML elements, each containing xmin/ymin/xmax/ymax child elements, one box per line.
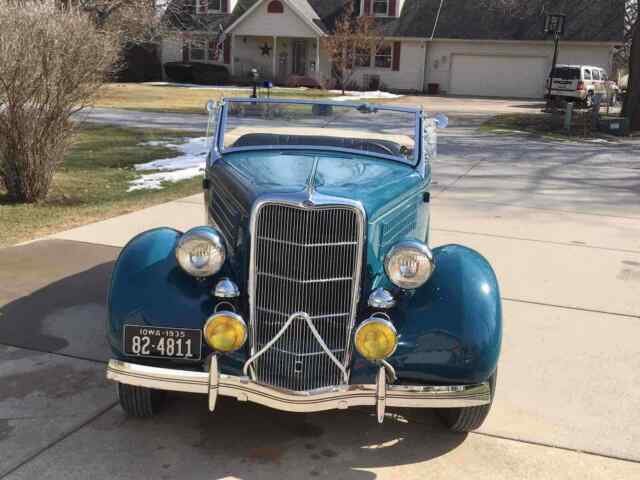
<box><xmin>222</xmin><ymin>151</ymin><xmax>425</xmax><ymax>221</ymax></box>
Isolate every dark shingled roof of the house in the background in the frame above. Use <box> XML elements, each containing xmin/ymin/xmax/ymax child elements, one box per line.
<box><xmin>165</xmin><ymin>0</ymin><xmax>625</xmax><ymax>42</ymax></box>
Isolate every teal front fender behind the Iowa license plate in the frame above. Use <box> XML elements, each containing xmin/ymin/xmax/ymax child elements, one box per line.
<box><xmin>107</xmin><ymin>228</ymin><xmax>241</xmax><ymax>363</ymax></box>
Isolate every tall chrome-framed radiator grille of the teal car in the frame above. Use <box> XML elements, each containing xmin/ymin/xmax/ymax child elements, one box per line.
<box><xmin>251</xmin><ymin>203</ymin><xmax>364</xmax><ymax>391</ymax></box>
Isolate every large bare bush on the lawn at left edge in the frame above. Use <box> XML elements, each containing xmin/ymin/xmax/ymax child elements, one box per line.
<box><xmin>0</xmin><ymin>0</ymin><xmax>119</xmax><ymax>202</ymax></box>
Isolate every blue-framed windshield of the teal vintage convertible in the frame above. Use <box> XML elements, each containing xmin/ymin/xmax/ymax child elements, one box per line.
<box><xmin>219</xmin><ymin>99</ymin><xmax>419</xmax><ymax>165</ymax></box>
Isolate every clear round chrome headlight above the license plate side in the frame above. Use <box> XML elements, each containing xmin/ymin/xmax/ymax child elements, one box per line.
<box><xmin>176</xmin><ymin>227</ymin><xmax>226</xmax><ymax>277</ymax></box>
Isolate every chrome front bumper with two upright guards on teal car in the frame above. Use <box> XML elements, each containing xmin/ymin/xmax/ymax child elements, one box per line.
<box><xmin>107</xmin><ymin>356</ymin><xmax>491</xmax><ymax>422</ymax></box>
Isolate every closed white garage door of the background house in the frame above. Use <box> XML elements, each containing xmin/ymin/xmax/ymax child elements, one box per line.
<box><xmin>450</xmin><ymin>55</ymin><xmax>548</xmax><ymax>98</ymax></box>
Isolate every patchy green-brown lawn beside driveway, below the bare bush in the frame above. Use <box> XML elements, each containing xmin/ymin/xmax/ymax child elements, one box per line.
<box><xmin>0</xmin><ymin>125</ymin><xmax>202</xmax><ymax>246</ymax></box>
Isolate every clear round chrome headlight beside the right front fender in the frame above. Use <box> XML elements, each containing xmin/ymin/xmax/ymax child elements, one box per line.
<box><xmin>384</xmin><ymin>241</ymin><xmax>436</xmax><ymax>289</ymax></box>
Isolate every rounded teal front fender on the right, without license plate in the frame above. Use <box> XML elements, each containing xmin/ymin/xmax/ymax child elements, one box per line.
<box><xmin>354</xmin><ymin>245</ymin><xmax>502</xmax><ymax>384</ymax></box>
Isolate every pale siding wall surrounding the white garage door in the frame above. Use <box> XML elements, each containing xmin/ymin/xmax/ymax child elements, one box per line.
<box><xmin>425</xmin><ymin>40</ymin><xmax>613</xmax><ymax>96</ymax></box>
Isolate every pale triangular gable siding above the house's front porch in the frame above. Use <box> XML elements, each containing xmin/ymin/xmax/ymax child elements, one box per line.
<box><xmin>233</xmin><ymin>1</ymin><xmax>317</xmax><ymax>37</ymax></box>
